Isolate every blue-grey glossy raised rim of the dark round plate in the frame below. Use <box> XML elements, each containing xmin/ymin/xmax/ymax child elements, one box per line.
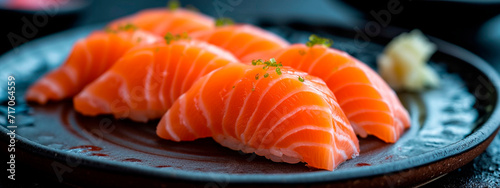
<box><xmin>0</xmin><ymin>24</ymin><xmax>500</xmax><ymax>183</ymax></box>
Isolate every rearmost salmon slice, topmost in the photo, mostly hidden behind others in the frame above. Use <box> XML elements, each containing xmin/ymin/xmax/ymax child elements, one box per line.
<box><xmin>108</xmin><ymin>8</ymin><xmax>215</xmax><ymax>36</ymax></box>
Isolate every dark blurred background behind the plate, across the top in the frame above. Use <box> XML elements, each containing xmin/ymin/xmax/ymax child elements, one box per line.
<box><xmin>0</xmin><ymin>0</ymin><xmax>500</xmax><ymax>70</ymax></box>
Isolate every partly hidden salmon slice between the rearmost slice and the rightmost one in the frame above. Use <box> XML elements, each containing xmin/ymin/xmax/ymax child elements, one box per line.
<box><xmin>191</xmin><ymin>24</ymin><xmax>289</xmax><ymax>62</ymax></box>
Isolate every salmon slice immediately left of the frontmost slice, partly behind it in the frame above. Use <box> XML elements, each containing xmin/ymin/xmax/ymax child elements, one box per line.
<box><xmin>73</xmin><ymin>41</ymin><xmax>238</xmax><ymax>122</ymax></box>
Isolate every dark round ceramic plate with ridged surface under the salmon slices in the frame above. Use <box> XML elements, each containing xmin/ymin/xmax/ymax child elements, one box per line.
<box><xmin>0</xmin><ymin>23</ymin><xmax>500</xmax><ymax>187</ymax></box>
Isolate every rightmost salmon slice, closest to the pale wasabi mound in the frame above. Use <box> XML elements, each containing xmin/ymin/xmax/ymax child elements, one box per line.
<box><xmin>276</xmin><ymin>44</ymin><xmax>410</xmax><ymax>143</ymax></box>
